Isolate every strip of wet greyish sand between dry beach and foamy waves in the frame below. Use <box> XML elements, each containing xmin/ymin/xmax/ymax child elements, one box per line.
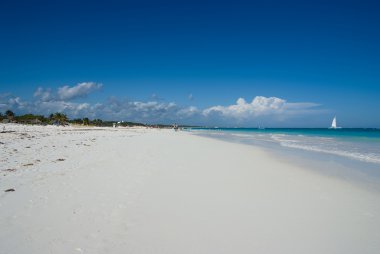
<box><xmin>188</xmin><ymin>131</ymin><xmax>380</xmax><ymax>191</ymax></box>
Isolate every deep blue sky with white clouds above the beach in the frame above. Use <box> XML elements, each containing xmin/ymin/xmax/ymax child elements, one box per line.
<box><xmin>0</xmin><ymin>1</ymin><xmax>380</xmax><ymax>127</ymax></box>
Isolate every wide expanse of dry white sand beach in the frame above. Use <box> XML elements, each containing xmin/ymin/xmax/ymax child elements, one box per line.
<box><xmin>0</xmin><ymin>124</ymin><xmax>380</xmax><ymax>254</ymax></box>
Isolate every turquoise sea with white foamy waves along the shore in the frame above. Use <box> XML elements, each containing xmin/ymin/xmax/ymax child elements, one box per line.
<box><xmin>187</xmin><ymin>128</ymin><xmax>380</xmax><ymax>165</ymax></box>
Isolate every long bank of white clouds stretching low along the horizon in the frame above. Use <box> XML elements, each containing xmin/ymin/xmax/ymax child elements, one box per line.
<box><xmin>0</xmin><ymin>82</ymin><xmax>322</xmax><ymax>126</ymax></box>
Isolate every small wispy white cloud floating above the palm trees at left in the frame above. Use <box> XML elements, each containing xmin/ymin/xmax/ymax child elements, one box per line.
<box><xmin>58</xmin><ymin>82</ymin><xmax>103</xmax><ymax>100</ymax></box>
